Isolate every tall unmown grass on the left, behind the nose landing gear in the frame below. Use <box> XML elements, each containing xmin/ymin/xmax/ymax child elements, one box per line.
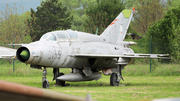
<box><xmin>0</xmin><ymin>60</ymin><xmax>71</xmax><ymax>77</ymax></box>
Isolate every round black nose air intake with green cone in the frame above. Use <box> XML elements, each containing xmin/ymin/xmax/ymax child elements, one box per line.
<box><xmin>16</xmin><ymin>47</ymin><xmax>30</xmax><ymax>62</ymax></box>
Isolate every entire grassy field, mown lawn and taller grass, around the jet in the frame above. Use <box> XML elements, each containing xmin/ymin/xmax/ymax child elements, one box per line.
<box><xmin>0</xmin><ymin>61</ymin><xmax>180</xmax><ymax>101</ymax></box>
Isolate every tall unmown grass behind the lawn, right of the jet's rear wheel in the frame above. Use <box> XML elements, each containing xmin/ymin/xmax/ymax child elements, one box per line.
<box><xmin>122</xmin><ymin>63</ymin><xmax>180</xmax><ymax>76</ymax></box>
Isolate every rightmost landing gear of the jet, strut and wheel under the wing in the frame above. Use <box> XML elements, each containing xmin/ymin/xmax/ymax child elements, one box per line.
<box><xmin>110</xmin><ymin>65</ymin><xmax>124</xmax><ymax>86</ymax></box>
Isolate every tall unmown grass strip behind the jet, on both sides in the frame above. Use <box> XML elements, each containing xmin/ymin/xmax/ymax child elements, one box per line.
<box><xmin>0</xmin><ymin>60</ymin><xmax>180</xmax><ymax>77</ymax></box>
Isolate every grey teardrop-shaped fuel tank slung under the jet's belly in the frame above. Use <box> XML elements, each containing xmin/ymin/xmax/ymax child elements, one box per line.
<box><xmin>57</xmin><ymin>72</ymin><xmax>101</xmax><ymax>82</ymax></box>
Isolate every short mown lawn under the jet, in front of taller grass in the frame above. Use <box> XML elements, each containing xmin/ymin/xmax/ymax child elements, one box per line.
<box><xmin>0</xmin><ymin>76</ymin><xmax>180</xmax><ymax>101</ymax></box>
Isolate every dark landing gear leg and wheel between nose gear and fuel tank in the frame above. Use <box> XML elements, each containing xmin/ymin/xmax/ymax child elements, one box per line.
<box><xmin>53</xmin><ymin>68</ymin><xmax>65</xmax><ymax>86</ymax></box>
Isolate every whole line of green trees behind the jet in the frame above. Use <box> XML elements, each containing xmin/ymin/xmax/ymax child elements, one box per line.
<box><xmin>0</xmin><ymin>0</ymin><xmax>180</xmax><ymax>61</ymax></box>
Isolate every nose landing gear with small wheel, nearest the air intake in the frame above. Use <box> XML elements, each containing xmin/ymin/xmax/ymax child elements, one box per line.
<box><xmin>42</xmin><ymin>67</ymin><xmax>49</xmax><ymax>89</ymax></box>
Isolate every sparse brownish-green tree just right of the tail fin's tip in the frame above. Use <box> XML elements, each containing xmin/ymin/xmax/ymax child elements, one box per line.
<box><xmin>132</xmin><ymin>0</ymin><xmax>167</xmax><ymax>35</ymax></box>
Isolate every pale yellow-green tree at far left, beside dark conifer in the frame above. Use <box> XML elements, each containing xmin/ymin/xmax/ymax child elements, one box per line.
<box><xmin>0</xmin><ymin>4</ymin><xmax>31</xmax><ymax>44</ymax></box>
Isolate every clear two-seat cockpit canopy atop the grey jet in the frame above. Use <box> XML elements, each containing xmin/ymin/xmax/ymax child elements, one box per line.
<box><xmin>40</xmin><ymin>30</ymin><xmax>78</xmax><ymax>41</ymax></box>
